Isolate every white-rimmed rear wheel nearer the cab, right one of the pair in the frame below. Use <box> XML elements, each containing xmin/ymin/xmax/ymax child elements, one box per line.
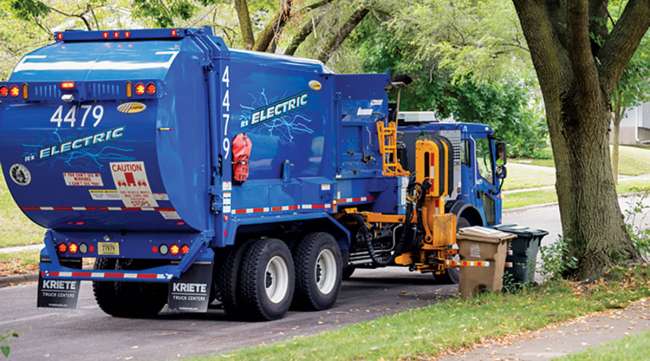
<box><xmin>294</xmin><ymin>232</ymin><xmax>343</xmax><ymax>311</ymax></box>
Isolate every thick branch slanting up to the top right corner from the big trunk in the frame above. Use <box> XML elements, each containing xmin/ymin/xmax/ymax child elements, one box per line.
<box><xmin>598</xmin><ymin>0</ymin><xmax>650</xmax><ymax>94</ymax></box>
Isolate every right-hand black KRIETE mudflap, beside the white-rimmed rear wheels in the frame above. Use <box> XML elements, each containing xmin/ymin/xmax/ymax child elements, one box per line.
<box><xmin>167</xmin><ymin>262</ymin><xmax>212</xmax><ymax>312</ymax></box>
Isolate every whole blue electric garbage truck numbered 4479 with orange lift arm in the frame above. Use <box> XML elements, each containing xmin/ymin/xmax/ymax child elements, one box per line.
<box><xmin>0</xmin><ymin>28</ymin><xmax>505</xmax><ymax>320</ymax></box>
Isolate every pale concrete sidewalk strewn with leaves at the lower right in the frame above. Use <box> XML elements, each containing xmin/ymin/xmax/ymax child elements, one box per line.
<box><xmin>438</xmin><ymin>299</ymin><xmax>650</xmax><ymax>361</ymax></box>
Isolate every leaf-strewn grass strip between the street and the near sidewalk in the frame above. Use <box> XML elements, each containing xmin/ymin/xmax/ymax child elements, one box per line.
<box><xmin>190</xmin><ymin>266</ymin><xmax>650</xmax><ymax>361</ymax></box>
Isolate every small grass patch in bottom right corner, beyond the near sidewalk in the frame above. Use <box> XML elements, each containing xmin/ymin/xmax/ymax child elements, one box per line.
<box><xmin>555</xmin><ymin>332</ymin><xmax>650</xmax><ymax>361</ymax></box>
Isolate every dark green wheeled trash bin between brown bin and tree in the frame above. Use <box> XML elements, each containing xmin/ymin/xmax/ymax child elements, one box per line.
<box><xmin>494</xmin><ymin>224</ymin><xmax>548</xmax><ymax>287</ymax></box>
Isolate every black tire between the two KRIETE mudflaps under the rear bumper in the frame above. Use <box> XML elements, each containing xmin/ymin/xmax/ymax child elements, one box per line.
<box><xmin>93</xmin><ymin>258</ymin><xmax>168</xmax><ymax>318</ymax></box>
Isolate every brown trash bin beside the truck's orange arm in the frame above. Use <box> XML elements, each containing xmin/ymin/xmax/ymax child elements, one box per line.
<box><xmin>456</xmin><ymin>227</ymin><xmax>516</xmax><ymax>298</ymax></box>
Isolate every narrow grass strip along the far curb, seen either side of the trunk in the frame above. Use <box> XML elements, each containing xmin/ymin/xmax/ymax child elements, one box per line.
<box><xmin>502</xmin><ymin>179</ymin><xmax>650</xmax><ymax>209</ymax></box>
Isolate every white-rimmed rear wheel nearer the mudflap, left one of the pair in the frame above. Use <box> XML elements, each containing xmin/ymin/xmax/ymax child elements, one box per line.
<box><xmin>237</xmin><ymin>239</ymin><xmax>295</xmax><ymax>321</ymax></box>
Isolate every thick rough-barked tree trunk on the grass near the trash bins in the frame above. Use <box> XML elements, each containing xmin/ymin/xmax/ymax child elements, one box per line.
<box><xmin>513</xmin><ymin>0</ymin><xmax>650</xmax><ymax>278</ymax></box>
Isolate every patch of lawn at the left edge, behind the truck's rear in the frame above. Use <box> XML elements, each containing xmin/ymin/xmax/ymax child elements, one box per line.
<box><xmin>0</xmin><ymin>172</ymin><xmax>43</xmax><ymax>248</ymax></box>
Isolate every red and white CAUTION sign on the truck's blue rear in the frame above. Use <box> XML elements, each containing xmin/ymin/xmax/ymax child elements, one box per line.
<box><xmin>110</xmin><ymin>162</ymin><xmax>158</xmax><ymax>208</ymax></box>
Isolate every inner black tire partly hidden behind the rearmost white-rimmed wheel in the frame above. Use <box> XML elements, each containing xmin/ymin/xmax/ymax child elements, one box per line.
<box><xmin>214</xmin><ymin>243</ymin><xmax>248</xmax><ymax>318</ymax></box>
